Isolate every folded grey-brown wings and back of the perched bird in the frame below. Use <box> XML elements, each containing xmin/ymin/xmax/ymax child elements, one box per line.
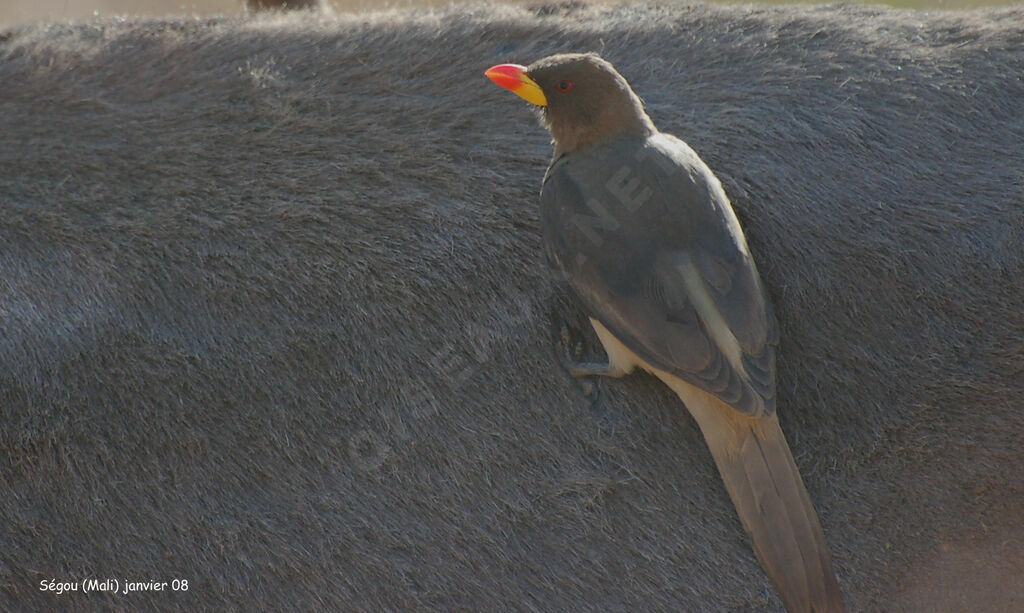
<box><xmin>541</xmin><ymin>135</ymin><xmax>777</xmax><ymax>415</ymax></box>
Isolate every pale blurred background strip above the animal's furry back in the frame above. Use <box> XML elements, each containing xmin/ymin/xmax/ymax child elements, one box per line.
<box><xmin>0</xmin><ymin>0</ymin><xmax>1020</xmax><ymax>27</ymax></box>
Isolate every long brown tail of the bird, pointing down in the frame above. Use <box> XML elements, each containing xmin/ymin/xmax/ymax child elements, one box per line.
<box><xmin>666</xmin><ymin>380</ymin><xmax>844</xmax><ymax>613</ymax></box>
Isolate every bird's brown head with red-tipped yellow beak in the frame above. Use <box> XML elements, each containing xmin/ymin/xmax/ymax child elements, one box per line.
<box><xmin>485</xmin><ymin>53</ymin><xmax>657</xmax><ymax>157</ymax></box>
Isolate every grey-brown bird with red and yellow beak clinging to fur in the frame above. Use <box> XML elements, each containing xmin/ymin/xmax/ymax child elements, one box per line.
<box><xmin>484</xmin><ymin>53</ymin><xmax>844</xmax><ymax>613</ymax></box>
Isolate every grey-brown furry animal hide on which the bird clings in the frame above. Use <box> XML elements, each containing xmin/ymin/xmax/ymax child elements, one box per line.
<box><xmin>0</xmin><ymin>4</ymin><xmax>1024</xmax><ymax>611</ymax></box>
